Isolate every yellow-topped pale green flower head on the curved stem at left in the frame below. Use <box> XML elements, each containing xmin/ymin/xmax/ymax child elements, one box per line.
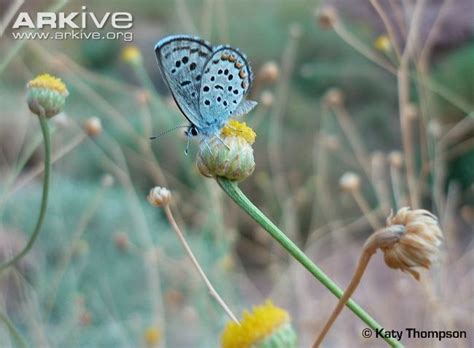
<box><xmin>26</xmin><ymin>74</ymin><xmax>69</xmax><ymax>118</ymax></box>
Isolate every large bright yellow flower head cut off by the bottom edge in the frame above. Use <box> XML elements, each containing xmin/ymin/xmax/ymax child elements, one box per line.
<box><xmin>221</xmin><ymin>300</ymin><xmax>296</xmax><ymax>348</ymax></box>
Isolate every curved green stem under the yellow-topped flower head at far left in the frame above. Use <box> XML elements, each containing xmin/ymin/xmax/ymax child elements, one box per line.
<box><xmin>0</xmin><ymin>116</ymin><xmax>51</xmax><ymax>273</ymax></box>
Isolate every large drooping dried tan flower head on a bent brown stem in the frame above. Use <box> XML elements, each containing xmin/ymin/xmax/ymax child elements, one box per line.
<box><xmin>382</xmin><ymin>207</ymin><xmax>443</xmax><ymax>280</ymax></box>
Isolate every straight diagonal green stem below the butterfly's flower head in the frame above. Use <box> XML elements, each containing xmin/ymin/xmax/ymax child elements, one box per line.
<box><xmin>216</xmin><ymin>177</ymin><xmax>403</xmax><ymax>347</ymax></box>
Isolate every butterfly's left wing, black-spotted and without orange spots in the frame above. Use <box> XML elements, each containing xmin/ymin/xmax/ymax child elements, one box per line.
<box><xmin>155</xmin><ymin>35</ymin><xmax>212</xmax><ymax>128</ymax></box>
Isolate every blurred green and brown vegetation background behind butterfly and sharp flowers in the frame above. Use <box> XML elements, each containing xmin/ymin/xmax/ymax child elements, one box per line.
<box><xmin>0</xmin><ymin>0</ymin><xmax>474</xmax><ymax>348</ymax></box>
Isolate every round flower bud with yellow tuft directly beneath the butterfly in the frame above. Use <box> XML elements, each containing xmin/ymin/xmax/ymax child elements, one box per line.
<box><xmin>197</xmin><ymin>120</ymin><xmax>256</xmax><ymax>181</ymax></box>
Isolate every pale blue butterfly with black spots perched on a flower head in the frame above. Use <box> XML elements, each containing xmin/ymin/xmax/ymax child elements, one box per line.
<box><xmin>155</xmin><ymin>35</ymin><xmax>257</xmax><ymax>148</ymax></box>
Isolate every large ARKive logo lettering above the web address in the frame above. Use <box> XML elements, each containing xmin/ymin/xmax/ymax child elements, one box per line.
<box><xmin>12</xmin><ymin>6</ymin><xmax>133</xmax><ymax>29</ymax></box>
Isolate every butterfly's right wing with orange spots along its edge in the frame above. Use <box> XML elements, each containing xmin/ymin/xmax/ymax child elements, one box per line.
<box><xmin>199</xmin><ymin>46</ymin><xmax>256</xmax><ymax>129</ymax></box>
